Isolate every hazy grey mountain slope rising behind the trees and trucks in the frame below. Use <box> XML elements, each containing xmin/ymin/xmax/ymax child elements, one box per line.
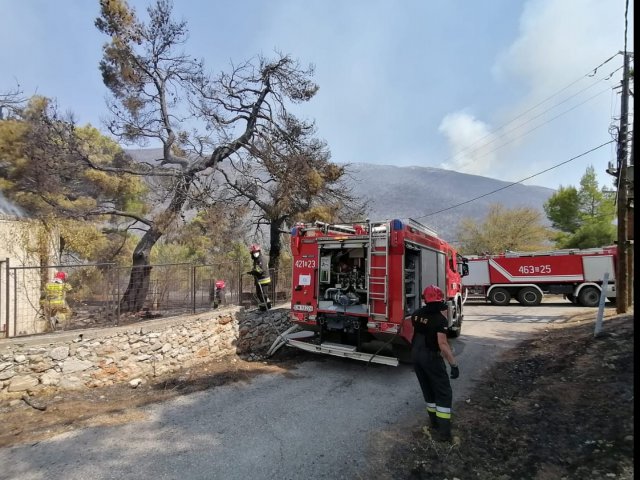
<box><xmin>127</xmin><ymin>149</ymin><xmax>554</xmax><ymax>241</ymax></box>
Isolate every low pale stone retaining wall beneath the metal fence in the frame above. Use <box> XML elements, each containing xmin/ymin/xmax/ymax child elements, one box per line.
<box><xmin>0</xmin><ymin>305</ymin><xmax>291</xmax><ymax>398</ymax></box>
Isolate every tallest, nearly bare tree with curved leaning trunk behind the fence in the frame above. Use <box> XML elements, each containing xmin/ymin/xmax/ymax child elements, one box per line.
<box><xmin>96</xmin><ymin>0</ymin><xmax>318</xmax><ymax>311</ymax></box>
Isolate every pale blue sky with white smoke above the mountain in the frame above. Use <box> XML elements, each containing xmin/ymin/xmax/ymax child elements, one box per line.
<box><xmin>0</xmin><ymin>0</ymin><xmax>633</xmax><ymax>189</ymax></box>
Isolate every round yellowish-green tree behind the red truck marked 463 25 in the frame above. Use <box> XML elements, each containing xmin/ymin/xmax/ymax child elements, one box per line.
<box><xmin>458</xmin><ymin>204</ymin><xmax>549</xmax><ymax>255</ymax></box>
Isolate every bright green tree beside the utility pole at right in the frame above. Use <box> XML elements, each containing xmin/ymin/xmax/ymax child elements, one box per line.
<box><xmin>544</xmin><ymin>166</ymin><xmax>616</xmax><ymax>248</ymax></box>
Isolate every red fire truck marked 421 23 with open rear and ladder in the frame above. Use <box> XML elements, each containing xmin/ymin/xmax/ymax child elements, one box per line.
<box><xmin>286</xmin><ymin>219</ymin><xmax>466</xmax><ymax>366</ymax></box>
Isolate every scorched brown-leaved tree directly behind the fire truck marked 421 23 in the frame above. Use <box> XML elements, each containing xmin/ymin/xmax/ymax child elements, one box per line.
<box><xmin>216</xmin><ymin>115</ymin><xmax>363</xmax><ymax>268</ymax></box>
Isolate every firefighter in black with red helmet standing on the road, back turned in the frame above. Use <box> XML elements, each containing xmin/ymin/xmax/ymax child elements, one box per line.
<box><xmin>411</xmin><ymin>285</ymin><xmax>460</xmax><ymax>441</ymax></box>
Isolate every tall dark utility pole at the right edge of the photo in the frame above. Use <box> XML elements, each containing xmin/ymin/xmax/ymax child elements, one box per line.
<box><xmin>616</xmin><ymin>50</ymin><xmax>629</xmax><ymax>313</ymax></box>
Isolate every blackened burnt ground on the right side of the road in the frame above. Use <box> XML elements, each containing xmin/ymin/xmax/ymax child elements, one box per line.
<box><xmin>385</xmin><ymin>313</ymin><xmax>634</xmax><ymax>480</ymax></box>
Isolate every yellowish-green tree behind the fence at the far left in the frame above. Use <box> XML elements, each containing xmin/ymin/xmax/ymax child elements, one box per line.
<box><xmin>0</xmin><ymin>96</ymin><xmax>146</xmax><ymax>261</ymax></box>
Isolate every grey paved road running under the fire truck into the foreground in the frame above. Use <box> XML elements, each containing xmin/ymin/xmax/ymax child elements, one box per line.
<box><xmin>0</xmin><ymin>302</ymin><xmax>596</xmax><ymax>480</ymax></box>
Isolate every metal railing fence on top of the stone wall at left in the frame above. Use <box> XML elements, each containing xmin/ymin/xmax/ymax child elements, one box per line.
<box><xmin>0</xmin><ymin>259</ymin><xmax>291</xmax><ymax>337</ymax></box>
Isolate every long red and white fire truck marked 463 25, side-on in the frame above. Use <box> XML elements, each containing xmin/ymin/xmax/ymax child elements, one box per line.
<box><xmin>462</xmin><ymin>246</ymin><xmax>617</xmax><ymax>307</ymax></box>
